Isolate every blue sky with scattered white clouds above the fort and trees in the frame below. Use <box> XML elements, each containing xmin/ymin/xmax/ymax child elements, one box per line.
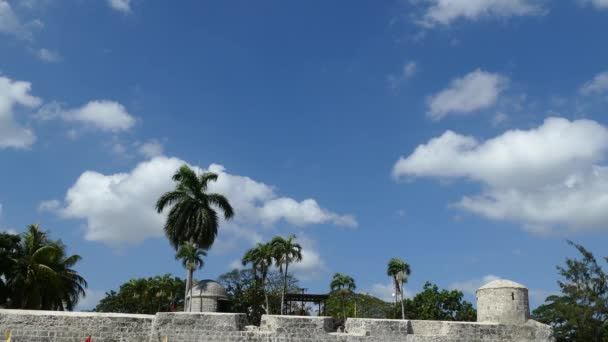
<box><xmin>0</xmin><ymin>0</ymin><xmax>608</xmax><ymax>308</ymax></box>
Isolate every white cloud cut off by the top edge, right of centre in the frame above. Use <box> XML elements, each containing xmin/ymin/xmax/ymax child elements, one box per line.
<box><xmin>420</xmin><ymin>0</ymin><xmax>540</xmax><ymax>28</ymax></box>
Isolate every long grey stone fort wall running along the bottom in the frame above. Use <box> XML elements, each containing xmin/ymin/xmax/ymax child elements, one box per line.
<box><xmin>0</xmin><ymin>310</ymin><xmax>554</xmax><ymax>342</ymax></box>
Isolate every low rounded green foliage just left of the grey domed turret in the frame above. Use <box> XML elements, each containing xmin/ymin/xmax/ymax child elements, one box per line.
<box><xmin>95</xmin><ymin>274</ymin><xmax>186</xmax><ymax>314</ymax></box>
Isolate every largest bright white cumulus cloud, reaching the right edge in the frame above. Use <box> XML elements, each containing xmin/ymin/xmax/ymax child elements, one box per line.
<box><xmin>393</xmin><ymin>118</ymin><xmax>608</xmax><ymax>235</ymax></box>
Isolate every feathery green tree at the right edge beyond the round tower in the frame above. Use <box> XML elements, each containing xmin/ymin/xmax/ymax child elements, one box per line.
<box><xmin>532</xmin><ymin>241</ymin><xmax>608</xmax><ymax>342</ymax></box>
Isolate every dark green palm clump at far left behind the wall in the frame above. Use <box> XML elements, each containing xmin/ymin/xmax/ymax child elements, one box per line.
<box><xmin>0</xmin><ymin>225</ymin><xmax>87</xmax><ymax>311</ymax></box>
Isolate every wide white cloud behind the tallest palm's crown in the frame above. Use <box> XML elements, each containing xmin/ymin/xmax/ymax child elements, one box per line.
<box><xmin>45</xmin><ymin>156</ymin><xmax>356</xmax><ymax>244</ymax></box>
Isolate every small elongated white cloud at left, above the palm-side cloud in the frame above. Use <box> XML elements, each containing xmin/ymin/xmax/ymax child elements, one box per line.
<box><xmin>36</xmin><ymin>100</ymin><xmax>135</xmax><ymax>133</ymax></box>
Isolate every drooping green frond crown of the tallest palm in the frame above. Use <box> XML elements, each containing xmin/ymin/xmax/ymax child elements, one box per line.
<box><xmin>156</xmin><ymin>165</ymin><xmax>234</xmax><ymax>250</ymax></box>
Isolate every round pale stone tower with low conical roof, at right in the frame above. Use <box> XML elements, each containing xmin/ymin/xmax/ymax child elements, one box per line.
<box><xmin>477</xmin><ymin>279</ymin><xmax>530</xmax><ymax>324</ymax></box>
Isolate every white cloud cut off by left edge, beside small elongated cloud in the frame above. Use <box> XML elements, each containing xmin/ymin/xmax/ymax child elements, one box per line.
<box><xmin>0</xmin><ymin>74</ymin><xmax>42</xmax><ymax>149</ymax></box>
